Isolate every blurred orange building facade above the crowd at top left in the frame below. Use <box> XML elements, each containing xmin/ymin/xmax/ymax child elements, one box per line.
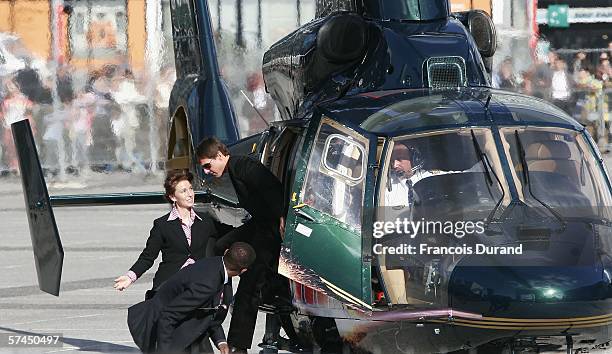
<box><xmin>0</xmin><ymin>0</ymin><xmax>171</xmax><ymax>71</ymax></box>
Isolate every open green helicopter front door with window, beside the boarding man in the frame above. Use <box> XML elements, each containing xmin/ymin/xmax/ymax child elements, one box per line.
<box><xmin>281</xmin><ymin>118</ymin><xmax>371</xmax><ymax>308</ymax></box>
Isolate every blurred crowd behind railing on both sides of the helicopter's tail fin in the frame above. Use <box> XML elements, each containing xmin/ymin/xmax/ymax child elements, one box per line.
<box><xmin>0</xmin><ymin>27</ymin><xmax>278</xmax><ymax>180</ymax></box>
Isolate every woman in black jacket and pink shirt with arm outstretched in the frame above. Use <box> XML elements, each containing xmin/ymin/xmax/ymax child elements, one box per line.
<box><xmin>114</xmin><ymin>170</ymin><xmax>222</xmax><ymax>298</ymax></box>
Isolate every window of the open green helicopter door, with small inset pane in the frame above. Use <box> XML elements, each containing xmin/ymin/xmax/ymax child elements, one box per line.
<box><xmin>302</xmin><ymin>121</ymin><xmax>367</xmax><ymax>230</ymax></box>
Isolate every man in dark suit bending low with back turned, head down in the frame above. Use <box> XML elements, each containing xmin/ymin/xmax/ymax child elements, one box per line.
<box><xmin>128</xmin><ymin>242</ymin><xmax>255</xmax><ymax>354</ymax></box>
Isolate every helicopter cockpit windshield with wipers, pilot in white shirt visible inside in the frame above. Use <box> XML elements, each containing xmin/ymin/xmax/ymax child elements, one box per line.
<box><xmin>373</xmin><ymin>125</ymin><xmax>612</xmax><ymax>306</ymax></box>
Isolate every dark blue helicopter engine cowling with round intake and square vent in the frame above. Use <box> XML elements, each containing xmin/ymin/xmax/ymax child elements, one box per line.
<box><xmin>262</xmin><ymin>12</ymin><xmax>489</xmax><ymax>119</ymax></box>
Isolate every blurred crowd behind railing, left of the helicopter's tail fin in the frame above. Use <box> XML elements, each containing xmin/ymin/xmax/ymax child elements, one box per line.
<box><xmin>0</xmin><ymin>62</ymin><xmax>175</xmax><ymax>178</ymax></box>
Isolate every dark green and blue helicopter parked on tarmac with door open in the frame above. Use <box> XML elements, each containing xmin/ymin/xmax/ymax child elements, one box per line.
<box><xmin>8</xmin><ymin>0</ymin><xmax>612</xmax><ymax>353</ymax></box>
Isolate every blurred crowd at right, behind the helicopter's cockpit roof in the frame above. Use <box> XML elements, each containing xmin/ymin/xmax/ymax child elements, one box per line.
<box><xmin>493</xmin><ymin>42</ymin><xmax>612</xmax><ymax>148</ymax></box>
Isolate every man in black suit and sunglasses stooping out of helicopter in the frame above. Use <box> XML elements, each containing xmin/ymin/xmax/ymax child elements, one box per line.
<box><xmin>197</xmin><ymin>137</ymin><xmax>285</xmax><ymax>353</ymax></box>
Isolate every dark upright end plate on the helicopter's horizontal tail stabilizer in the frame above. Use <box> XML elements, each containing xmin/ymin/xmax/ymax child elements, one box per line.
<box><xmin>11</xmin><ymin>119</ymin><xmax>64</xmax><ymax>296</ymax></box>
